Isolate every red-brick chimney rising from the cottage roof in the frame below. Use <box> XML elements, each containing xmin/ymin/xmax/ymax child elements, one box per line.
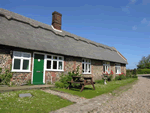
<box><xmin>52</xmin><ymin>11</ymin><xmax>62</xmax><ymax>30</ymax></box>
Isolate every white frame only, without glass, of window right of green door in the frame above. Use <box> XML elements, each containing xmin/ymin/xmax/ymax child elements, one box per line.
<box><xmin>45</xmin><ymin>54</ymin><xmax>64</xmax><ymax>71</ymax></box>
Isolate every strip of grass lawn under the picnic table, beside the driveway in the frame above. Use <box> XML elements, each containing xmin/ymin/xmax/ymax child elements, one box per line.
<box><xmin>51</xmin><ymin>78</ymin><xmax>138</xmax><ymax>99</ymax></box>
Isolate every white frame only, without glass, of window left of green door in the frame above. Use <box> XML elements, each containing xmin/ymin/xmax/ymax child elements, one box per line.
<box><xmin>11</xmin><ymin>51</ymin><xmax>31</xmax><ymax>72</ymax></box>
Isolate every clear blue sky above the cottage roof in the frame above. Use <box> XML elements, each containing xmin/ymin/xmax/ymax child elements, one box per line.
<box><xmin>0</xmin><ymin>0</ymin><xmax>150</xmax><ymax>69</ymax></box>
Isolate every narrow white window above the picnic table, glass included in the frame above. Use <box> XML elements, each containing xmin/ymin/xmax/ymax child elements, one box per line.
<box><xmin>82</xmin><ymin>59</ymin><xmax>91</xmax><ymax>74</ymax></box>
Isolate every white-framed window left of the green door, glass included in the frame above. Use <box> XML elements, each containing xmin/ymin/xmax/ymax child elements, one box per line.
<box><xmin>12</xmin><ymin>51</ymin><xmax>31</xmax><ymax>72</ymax></box>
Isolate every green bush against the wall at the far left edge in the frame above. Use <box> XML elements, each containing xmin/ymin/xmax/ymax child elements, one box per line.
<box><xmin>0</xmin><ymin>69</ymin><xmax>12</xmax><ymax>85</ymax></box>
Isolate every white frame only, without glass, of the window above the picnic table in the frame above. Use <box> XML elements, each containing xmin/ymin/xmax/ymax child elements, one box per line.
<box><xmin>82</xmin><ymin>59</ymin><xmax>91</xmax><ymax>74</ymax></box>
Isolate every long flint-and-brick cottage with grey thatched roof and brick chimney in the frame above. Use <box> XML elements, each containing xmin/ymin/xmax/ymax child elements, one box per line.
<box><xmin>0</xmin><ymin>9</ymin><xmax>127</xmax><ymax>84</ymax></box>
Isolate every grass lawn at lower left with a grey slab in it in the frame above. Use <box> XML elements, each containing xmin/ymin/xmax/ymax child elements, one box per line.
<box><xmin>0</xmin><ymin>90</ymin><xmax>73</xmax><ymax>113</ymax></box>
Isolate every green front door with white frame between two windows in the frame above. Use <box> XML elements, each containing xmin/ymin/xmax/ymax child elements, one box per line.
<box><xmin>33</xmin><ymin>54</ymin><xmax>44</xmax><ymax>84</ymax></box>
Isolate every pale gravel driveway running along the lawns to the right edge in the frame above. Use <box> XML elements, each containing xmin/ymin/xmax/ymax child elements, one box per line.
<box><xmin>51</xmin><ymin>75</ymin><xmax>150</xmax><ymax>113</ymax></box>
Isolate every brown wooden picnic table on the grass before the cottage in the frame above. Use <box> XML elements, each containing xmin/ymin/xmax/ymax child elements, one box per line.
<box><xmin>68</xmin><ymin>76</ymin><xmax>95</xmax><ymax>92</ymax></box>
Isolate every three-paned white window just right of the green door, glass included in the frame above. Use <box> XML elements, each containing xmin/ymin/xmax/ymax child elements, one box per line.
<box><xmin>46</xmin><ymin>55</ymin><xmax>64</xmax><ymax>71</ymax></box>
